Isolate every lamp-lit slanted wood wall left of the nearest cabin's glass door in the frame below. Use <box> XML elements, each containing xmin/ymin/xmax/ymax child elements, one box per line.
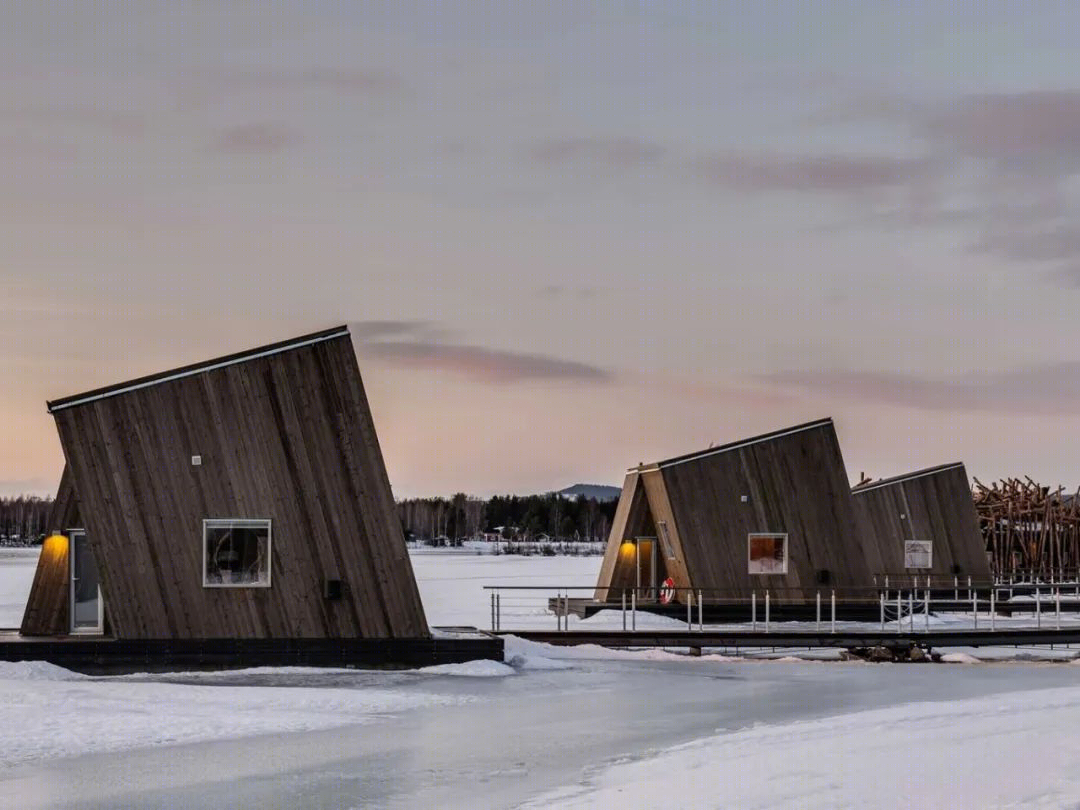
<box><xmin>19</xmin><ymin>468</ymin><xmax>81</xmax><ymax>636</ymax></box>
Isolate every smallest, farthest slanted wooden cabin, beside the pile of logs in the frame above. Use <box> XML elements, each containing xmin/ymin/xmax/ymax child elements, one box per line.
<box><xmin>851</xmin><ymin>462</ymin><xmax>990</xmax><ymax>581</ymax></box>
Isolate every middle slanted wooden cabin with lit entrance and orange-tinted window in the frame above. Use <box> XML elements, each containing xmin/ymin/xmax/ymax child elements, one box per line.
<box><xmin>595</xmin><ymin>419</ymin><xmax>880</xmax><ymax>602</ymax></box>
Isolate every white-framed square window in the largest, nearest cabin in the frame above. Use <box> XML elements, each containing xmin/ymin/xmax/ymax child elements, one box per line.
<box><xmin>203</xmin><ymin>519</ymin><xmax>270</xmax><ymax>588</ymax></box>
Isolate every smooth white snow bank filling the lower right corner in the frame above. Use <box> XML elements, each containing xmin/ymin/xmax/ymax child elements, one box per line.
<box><xmin>524</xmin><ymin>688</ymin><xmax>1080</xmax><ymax>810</ymax></box>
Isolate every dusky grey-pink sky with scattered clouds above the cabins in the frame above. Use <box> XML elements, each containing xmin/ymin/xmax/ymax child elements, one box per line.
<box><xmin>0</xmin><ymin>0</ymin><xmax>1080</xmax><ymax>497</ymax></box>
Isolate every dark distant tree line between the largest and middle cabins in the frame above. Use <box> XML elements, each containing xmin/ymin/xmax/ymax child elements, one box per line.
<box><xmin>397</xmin><ymin>492</ymin><xmax>617</xmax><ymax>542</ymax></box>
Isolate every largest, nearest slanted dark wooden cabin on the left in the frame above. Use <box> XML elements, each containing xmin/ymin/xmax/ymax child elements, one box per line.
<box><xmin>22</xmin><ymin>326</ymin><xmax>430</xmax><ymax>639</ymax></box>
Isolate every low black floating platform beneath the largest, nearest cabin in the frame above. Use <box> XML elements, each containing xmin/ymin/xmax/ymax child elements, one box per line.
<box><xmin>0</xmin><ymin>627</ymin><xmax>503</xmax><ymax>675</ymax></box>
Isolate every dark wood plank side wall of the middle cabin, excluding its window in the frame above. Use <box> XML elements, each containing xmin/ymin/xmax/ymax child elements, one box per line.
<box><xmin>599</xmin><ymin>420</ymin><xmax>879</xmax><ymax>599</ymax></box>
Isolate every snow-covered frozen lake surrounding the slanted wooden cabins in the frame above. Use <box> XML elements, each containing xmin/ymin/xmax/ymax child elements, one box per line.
<box><xmin>6</xmin><ymin>552</ymin><xmax>1080</xmax><ymax>810</ymax></box>
